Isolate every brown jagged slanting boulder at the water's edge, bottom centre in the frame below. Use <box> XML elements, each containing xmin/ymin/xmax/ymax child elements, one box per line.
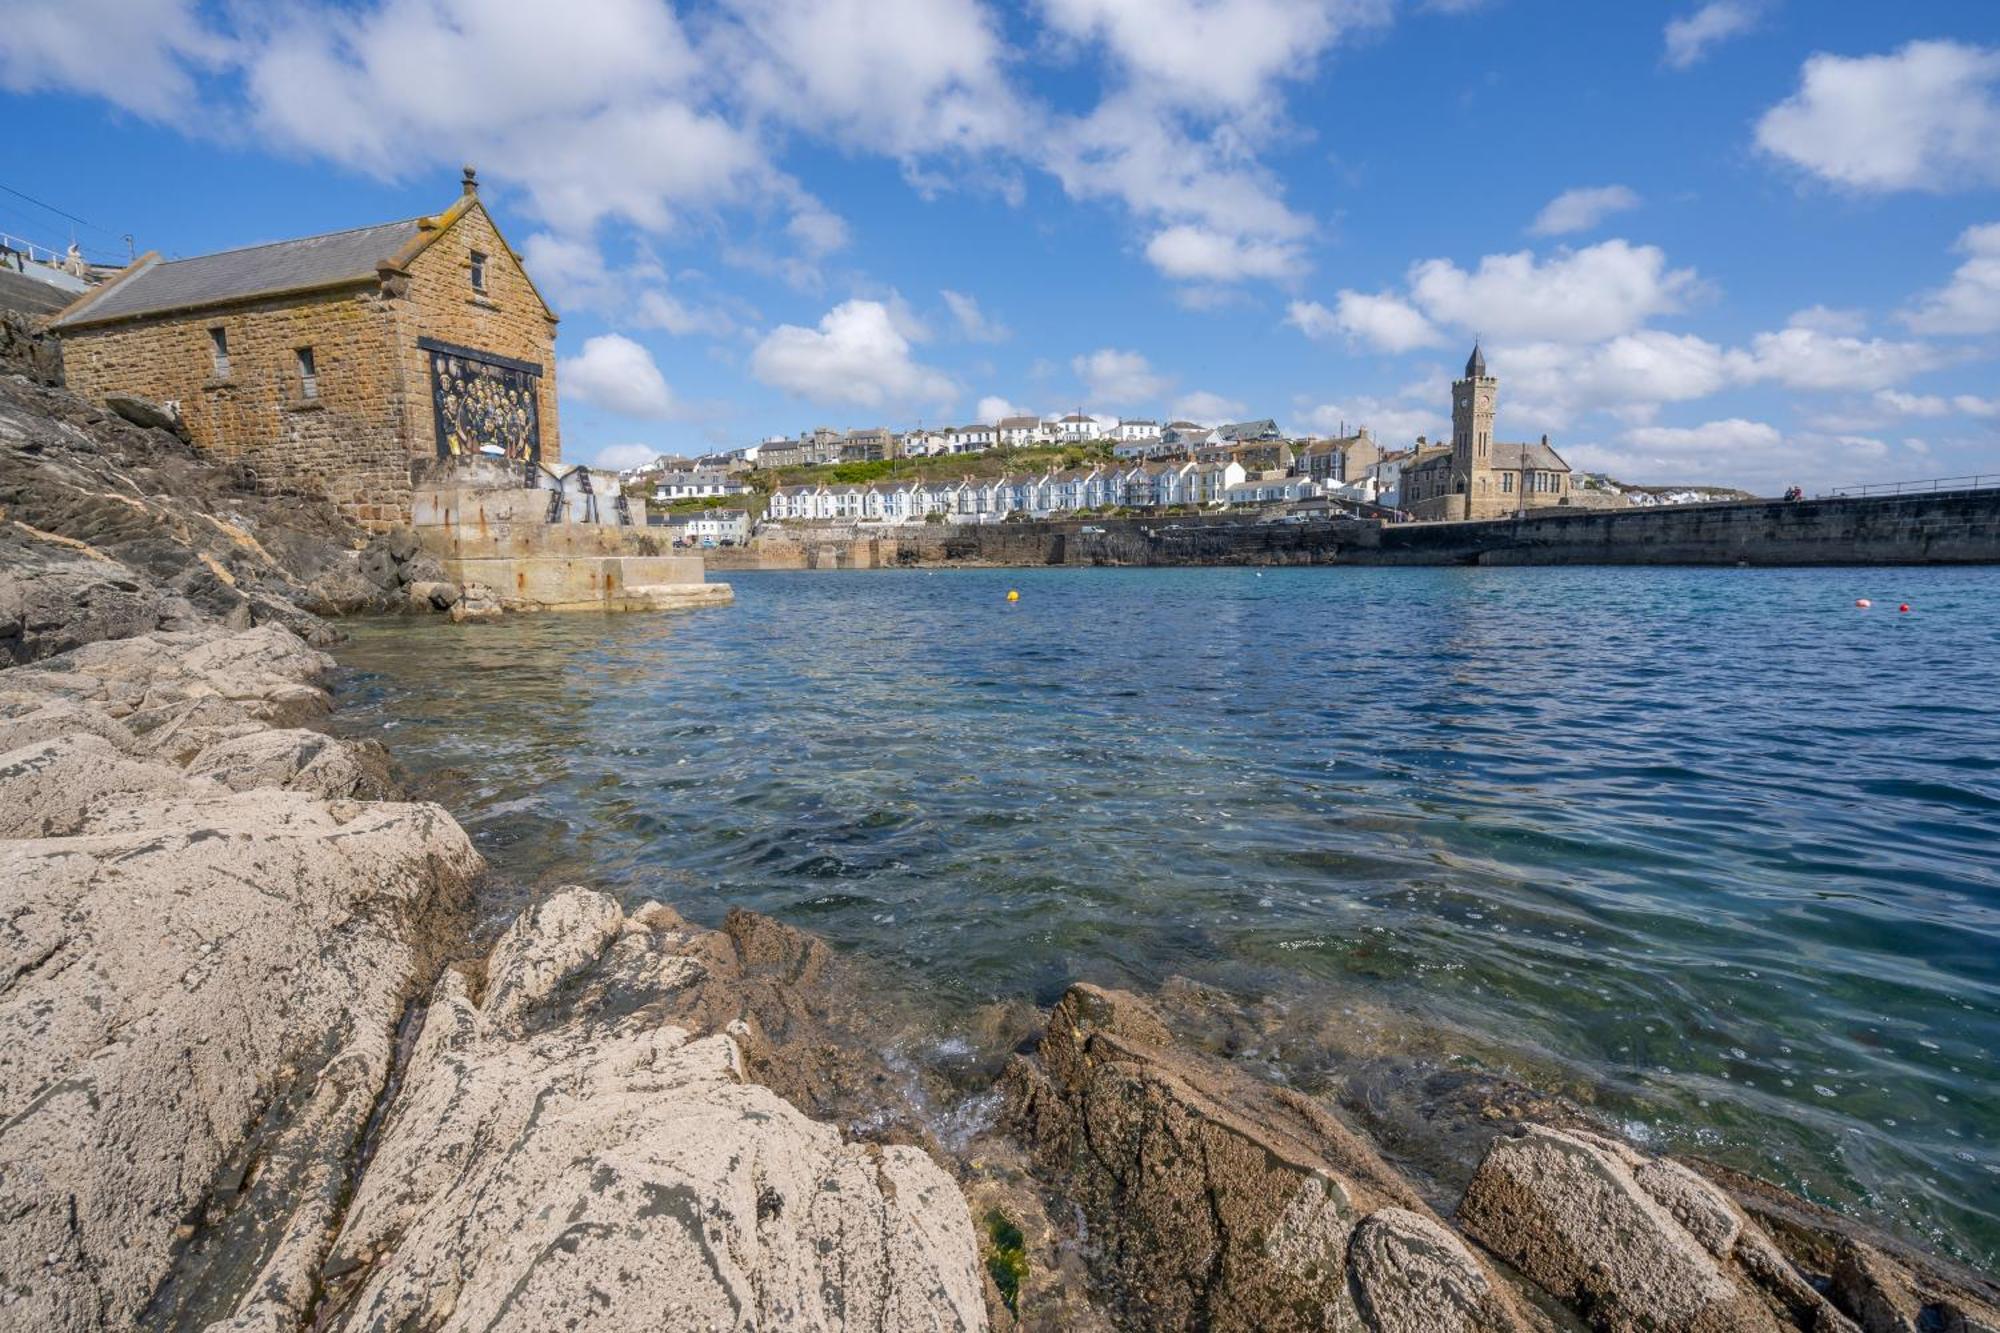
<box><xmin>1006</xmin><ymin>985</ymin><xmax>1528</xmax><ymax>1331</ymax></box>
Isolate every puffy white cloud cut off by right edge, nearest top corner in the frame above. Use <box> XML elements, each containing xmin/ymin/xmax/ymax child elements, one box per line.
<box><xmin>1756</xmin><ymin>42</ymin><xmax>2000</xmax><ymax>190</ymax></box>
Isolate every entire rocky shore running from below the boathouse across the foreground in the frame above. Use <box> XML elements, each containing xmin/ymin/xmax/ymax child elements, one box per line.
<box><xmin>0</xmin><ymin>326</ymin><xmax>2000</xmax><ymax>1333</ymax></box>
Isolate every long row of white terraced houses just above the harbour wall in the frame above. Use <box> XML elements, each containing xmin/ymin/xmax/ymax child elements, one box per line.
<box><xmin>764</xmin><ymin>458</ymin><xmax>1324</xmax><ymax>522</ymax></box>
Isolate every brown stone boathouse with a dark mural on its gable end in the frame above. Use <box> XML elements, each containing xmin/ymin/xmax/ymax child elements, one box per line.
<box><xmin>52</xmin><ymin>166</ymin><xmax>562</xmax><ymax>528</ymax></box>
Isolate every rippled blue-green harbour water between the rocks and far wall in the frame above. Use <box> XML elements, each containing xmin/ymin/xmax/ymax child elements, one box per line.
<box><xmin>340</xmin><ymin>568</ymin><xmax>2000</xmax><ymax>1269</ymax></box>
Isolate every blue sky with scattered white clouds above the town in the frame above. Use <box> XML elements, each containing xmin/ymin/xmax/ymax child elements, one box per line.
<box><xmin>0</xmin><ymin>0</ymin><xmax>2000</xmax><ymax>490</ymax></box>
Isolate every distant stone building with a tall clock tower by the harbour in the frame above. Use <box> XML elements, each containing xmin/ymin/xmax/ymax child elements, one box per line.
<box><xmin>1400</xmin><ymin>346</ymin><xmax>1570</xmax><ymax>518</ymax></box>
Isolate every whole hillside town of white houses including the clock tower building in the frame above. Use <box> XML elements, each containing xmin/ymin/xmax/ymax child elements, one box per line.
<box><xmin>620</xmin><ymin>346</ymin><xmax>1744</xmax><ymax>546</ymax></box>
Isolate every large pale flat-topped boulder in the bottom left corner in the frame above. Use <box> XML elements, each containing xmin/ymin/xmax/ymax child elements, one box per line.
<box><xmin>0</xmin><ymin>791</ymin><xmax>480</xmax><ymax>1331</ymax></box>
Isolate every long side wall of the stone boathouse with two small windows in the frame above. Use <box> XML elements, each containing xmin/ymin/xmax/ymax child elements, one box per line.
<box><xmin>64</xmin><ymin>288</ymin><xmax>410</xmax><ymax>528</ymax></box>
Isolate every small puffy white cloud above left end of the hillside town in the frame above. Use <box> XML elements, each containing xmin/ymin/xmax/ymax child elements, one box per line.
<box><xmin>750</xmin><ymin>300</ymin><xmax>958</xmax><ymax>410</ymax></box>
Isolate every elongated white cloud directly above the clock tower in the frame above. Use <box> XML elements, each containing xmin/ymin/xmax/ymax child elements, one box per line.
<box><xmin>1410</xmin><ymin>240</ymin><xmax>1698</xmax><ymax>342</ymax></box>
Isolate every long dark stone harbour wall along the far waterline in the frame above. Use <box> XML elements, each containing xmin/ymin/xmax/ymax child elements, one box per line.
<box><xmin>706</xmin><ymin>488</ymin><xmax>2000</xmax><ymax>570</ymax></box>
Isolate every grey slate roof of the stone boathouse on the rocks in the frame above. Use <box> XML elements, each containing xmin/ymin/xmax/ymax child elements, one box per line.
<box><xmin>54</xmin><ymin>218</ymin><xmax>420</xmax><ymax>328</ymax></box>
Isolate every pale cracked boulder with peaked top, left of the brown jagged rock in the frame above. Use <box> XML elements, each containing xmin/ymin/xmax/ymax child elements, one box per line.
<box><xmin>318</xmin><ymin>889</ymin><xmax>986</xmax><ymax>1333</ymax></box>
